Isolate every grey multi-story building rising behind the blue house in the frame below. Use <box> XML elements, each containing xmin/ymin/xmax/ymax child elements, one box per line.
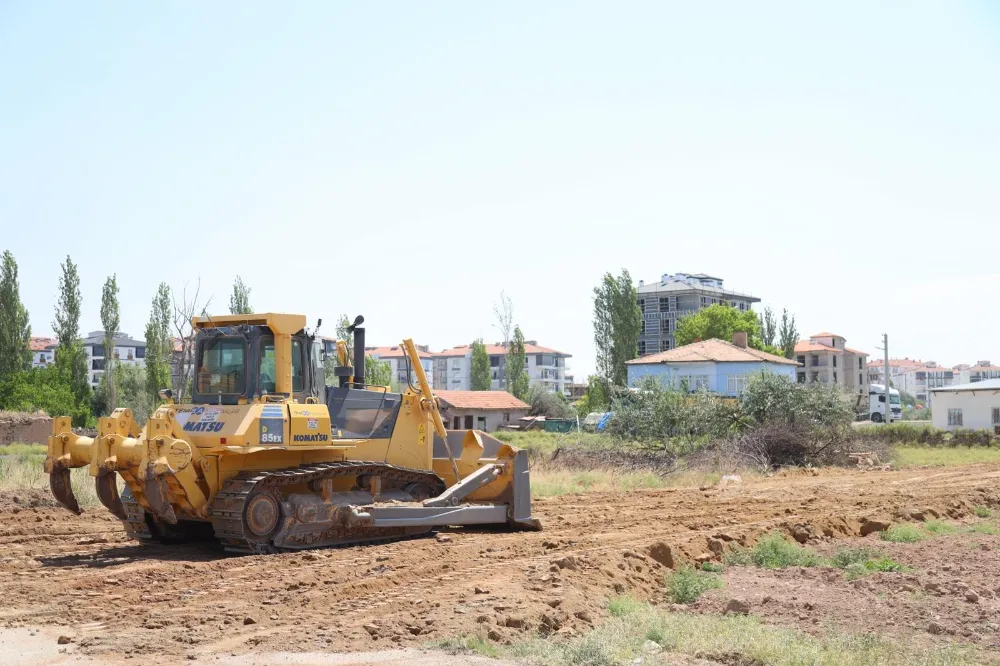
<box><xmin>638</xmin><ymin>273</ymin><xmax>760</xmax><ymax>356</ymax></box>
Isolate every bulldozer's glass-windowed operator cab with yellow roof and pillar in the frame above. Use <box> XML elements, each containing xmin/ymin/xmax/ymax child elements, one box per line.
<box><xmin>191</xmin><ymin>315</ymin><xmax>325</xmax><ymax>405</ymax></box>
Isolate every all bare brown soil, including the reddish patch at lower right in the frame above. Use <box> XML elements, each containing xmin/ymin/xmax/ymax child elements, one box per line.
<box><xmin>0</xmin><ymin>465</ymin><xmax>1000</xmax><ymax>664</ymax></box>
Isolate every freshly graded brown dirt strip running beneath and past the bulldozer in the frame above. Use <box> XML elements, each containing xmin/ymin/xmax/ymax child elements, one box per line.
<box><xmin>0</xmin><ymin>465</ymin><xmax>1000</xmax><ymax>663</ymax></box>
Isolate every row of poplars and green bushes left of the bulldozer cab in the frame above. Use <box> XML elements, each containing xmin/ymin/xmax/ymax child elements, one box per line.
<box><xmin>0</xmin><ymin>250</ymin><xmax>262</xmax><ymax>427</ymax></box>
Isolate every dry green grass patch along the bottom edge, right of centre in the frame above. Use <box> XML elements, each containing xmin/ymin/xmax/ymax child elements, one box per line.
<box><xmin>472</xmin><ymin>599</ymin><xmax>982</xmax><ymax>666</ymax></box>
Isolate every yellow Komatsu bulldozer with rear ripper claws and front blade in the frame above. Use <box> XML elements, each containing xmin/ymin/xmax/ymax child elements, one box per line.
<box><xmin>44</xmin><ymin>314</ymin><xmax>540</xmax><ymax>553</ymax></box>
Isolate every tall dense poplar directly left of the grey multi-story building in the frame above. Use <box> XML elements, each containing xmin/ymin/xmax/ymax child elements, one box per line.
<box><xmin>594</xmin><ymin>269</ymin><xmax>642</xmax><ymax>386</ymax></box>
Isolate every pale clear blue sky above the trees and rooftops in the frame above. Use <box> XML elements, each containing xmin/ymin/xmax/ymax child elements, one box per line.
<box><xmin>0</xmin><ymin>0</ymin><xmax>1000</xmax><ymax>378</ymax></box>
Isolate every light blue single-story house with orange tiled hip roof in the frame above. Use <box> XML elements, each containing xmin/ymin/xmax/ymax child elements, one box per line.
<box><xmin>626</xmin><ymin>333</ymin><xmax>799</xmax><ymax>397</ymax></box>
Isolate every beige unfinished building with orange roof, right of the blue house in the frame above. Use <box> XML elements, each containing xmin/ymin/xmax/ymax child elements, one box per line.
<box><xmin>795</xmin><ymin>332</ymin><xmax>870</xmax><ymax>396</ymax></box>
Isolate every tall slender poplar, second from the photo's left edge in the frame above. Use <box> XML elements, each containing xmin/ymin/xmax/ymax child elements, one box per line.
<box><xmin>52</xmin><ymin>255</ymin><xmax>92</xmax><ymax>427</ymax></box>
